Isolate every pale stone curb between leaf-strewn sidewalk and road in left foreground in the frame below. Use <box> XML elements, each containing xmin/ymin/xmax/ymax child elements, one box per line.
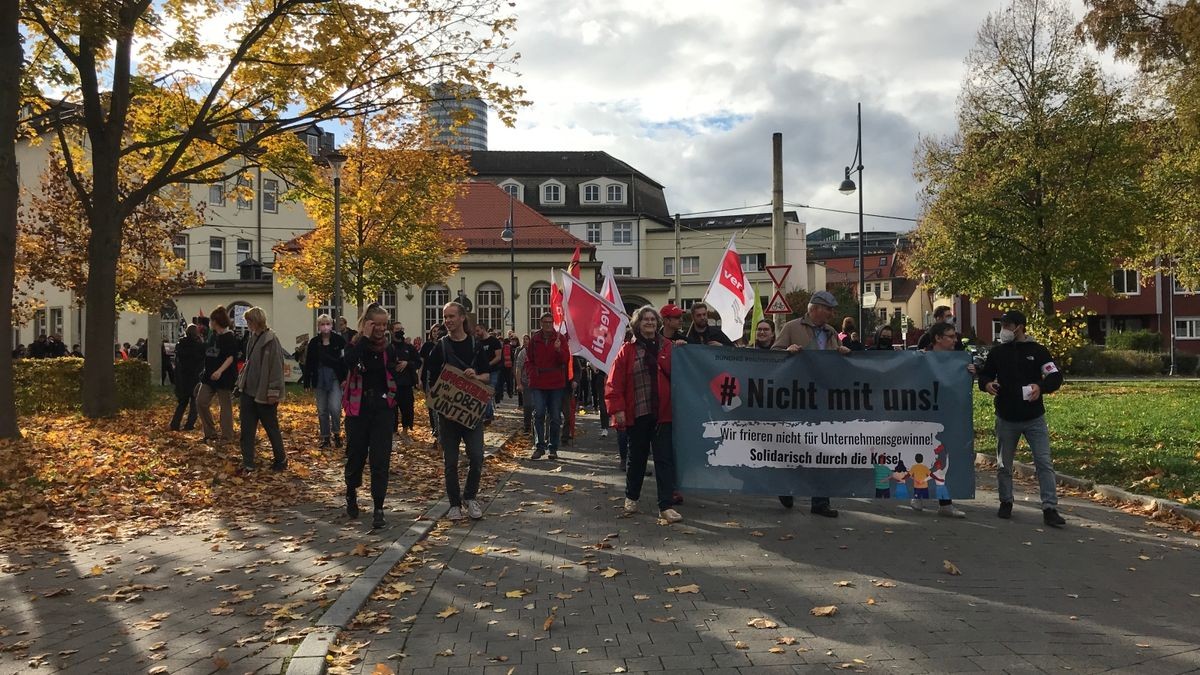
<box><xmin>286</xmin><ymin>498</ymin><xmax>450</xmax><ymax>675</ymax></box>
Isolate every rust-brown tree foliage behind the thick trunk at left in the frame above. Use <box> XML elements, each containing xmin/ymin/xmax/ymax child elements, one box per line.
<box><xmin>17</xmin><ymin>151</ymin><xmax>204</xmax><ymax>312</ymax></box>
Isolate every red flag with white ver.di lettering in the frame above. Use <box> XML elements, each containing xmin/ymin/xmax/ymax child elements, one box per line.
<box><xmin>562</xmin><ymin>269</ymin><xmax>629</xmax><ymax>372</ymax></box>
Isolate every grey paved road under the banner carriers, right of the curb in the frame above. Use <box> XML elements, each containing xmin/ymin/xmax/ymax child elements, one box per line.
<box><xmin>342</xmin><ymin>410</ymin><xmax>1200</xmax><ymax>675</ymax></box>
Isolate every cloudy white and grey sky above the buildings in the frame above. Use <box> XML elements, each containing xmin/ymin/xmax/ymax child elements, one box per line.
<box><xmin>488</xmin><ymin>0</ymin><xmax>1118</xmax><ymax>231</ymax></box>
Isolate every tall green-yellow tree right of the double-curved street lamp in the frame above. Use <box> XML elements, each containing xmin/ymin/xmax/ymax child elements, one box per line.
<box><xmin>906</xmin><ymin>0</ymin><xmax>1145</xmax><ymax>317</ymax></box>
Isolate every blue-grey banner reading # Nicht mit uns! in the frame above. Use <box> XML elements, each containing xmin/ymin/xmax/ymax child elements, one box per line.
<box><xmin>671</xmin><ymin>345</ymin><xmax>974</xmax><ymax>498</ymax></box>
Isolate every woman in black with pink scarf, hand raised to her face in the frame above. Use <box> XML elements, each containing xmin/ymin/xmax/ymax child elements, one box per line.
<box><xmin>342</xmin><ymin>303</ymin><xmax>400</xmax><ymax>528</ymax></box>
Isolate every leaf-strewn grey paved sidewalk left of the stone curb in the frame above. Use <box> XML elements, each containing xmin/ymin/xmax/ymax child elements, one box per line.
<box><xmin>0</xmin><ymin>430</ymin><xmax>508</xmax><ymax>675</ymax></box>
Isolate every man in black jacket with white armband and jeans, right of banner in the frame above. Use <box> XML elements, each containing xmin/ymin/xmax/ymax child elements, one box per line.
<box><xmin>979</xmin><ymin>310</ymin><xmax>1067</xmax><ymax>527</ymax></box>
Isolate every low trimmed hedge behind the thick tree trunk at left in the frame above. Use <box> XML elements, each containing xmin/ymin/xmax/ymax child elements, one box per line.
<box><xmin>12</xmin><ymin>357</ymin><xmax>150</xmax><ymax>414</ymax></box>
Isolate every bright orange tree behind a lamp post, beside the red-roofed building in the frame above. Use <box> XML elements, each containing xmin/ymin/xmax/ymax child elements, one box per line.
<box><xmin>275</xmin><ymin>120</ymin><xmax>469</xmax><ymax>309</ymax></box>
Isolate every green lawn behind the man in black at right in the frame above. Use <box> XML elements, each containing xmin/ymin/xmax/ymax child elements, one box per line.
<box><xmin>974</xmin><ymin>381</ymin><xmax>1200</xmax><ymax>506</ymax></box>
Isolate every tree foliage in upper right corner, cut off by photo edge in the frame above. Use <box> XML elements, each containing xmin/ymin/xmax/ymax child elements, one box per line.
<box><xmin>1078</xmin><ymin>0</ymin><xmax>1200</xmax><ymax>288</ymax></box>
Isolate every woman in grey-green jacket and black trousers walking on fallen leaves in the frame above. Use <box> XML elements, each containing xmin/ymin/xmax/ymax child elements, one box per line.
<box><xmin>238</xmin><ymin>307</ymin><xmax>288</xmax><ymax>472</ymax></box>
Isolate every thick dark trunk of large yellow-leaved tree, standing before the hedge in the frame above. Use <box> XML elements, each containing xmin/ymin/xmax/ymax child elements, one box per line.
<box><xmin>80</xmin><ymin>153</ymin><xmax>122</xmax><ymax>418</ymax></box>
